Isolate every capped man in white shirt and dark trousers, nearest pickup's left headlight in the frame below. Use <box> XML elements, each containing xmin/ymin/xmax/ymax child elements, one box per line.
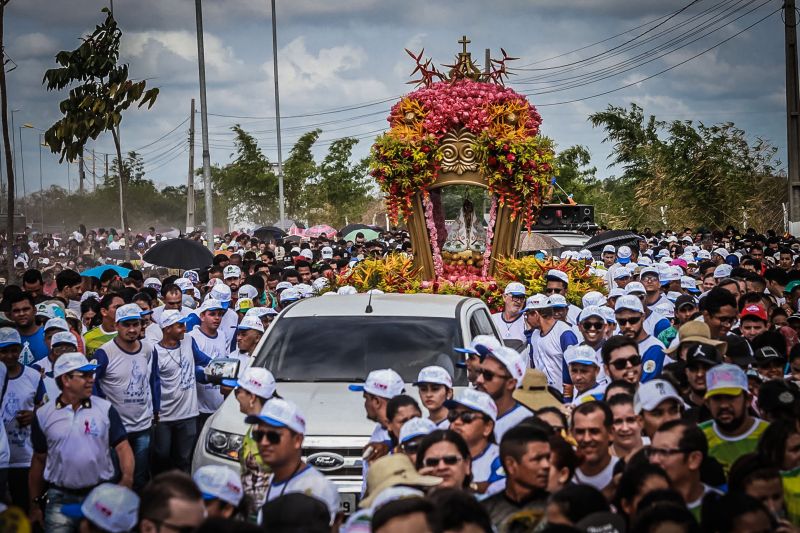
<box><xmin>153</xmin><ymin>309</ymin><xmax>211</xmax><ymax>473</ymax></box>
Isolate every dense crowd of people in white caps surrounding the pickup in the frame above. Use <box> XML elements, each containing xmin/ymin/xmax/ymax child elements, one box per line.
<box><xmin>0</xmin><ymin>224</ymin><xmax>800</xmax><ymax>533</ymax></box>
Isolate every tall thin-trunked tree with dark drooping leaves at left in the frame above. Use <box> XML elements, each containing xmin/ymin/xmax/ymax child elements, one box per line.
<box><xmin>42</xmin><ymin>8</ymin><xmax>158</xmax><ymax>243</ymax></box>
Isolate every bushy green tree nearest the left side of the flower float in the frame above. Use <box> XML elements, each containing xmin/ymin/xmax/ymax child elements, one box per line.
<box><xmin>308</xmin><ymin>137</ymin><xmax>372</xmax><ymax>227</ymax></box>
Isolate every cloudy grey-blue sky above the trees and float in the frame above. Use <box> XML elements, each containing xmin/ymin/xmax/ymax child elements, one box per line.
<box><xmin>5</xmin><ymin>0</ymin><xmax>786</xmax><ymax>202</ymax></box>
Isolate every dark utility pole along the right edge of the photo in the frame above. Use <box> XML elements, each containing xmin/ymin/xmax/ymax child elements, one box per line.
<box><xmin>783</xmin><ymin>0</ymin><xmax>800</xmax><ymax>222</ymax></box>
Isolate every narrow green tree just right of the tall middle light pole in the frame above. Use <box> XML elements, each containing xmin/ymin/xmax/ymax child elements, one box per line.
<box><xmin>283</xmin><ymin>129</ymin><xmax>322</xmax><ymax>219</ymax></box>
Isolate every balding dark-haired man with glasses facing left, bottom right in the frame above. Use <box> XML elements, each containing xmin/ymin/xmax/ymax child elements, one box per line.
<box><xmin>646</xmin><ymin>420</ymin><xmax>718</xmax><ymax>522</ymax></box>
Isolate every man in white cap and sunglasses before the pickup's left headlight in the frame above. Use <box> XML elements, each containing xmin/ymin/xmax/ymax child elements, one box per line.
<box><xmin>245</xmin><ymin>398</ymin><xmax>339</xmax><ymax>521</ymax></box>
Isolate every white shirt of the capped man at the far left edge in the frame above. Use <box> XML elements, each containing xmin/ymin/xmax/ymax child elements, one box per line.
<box><xmin>2</xmin><ymin>365</ymin><xmax>44</xmax><ymax>468</ymax></box>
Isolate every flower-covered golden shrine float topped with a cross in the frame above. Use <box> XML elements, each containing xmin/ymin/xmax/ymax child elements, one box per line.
<box><xmin>322</xmin><ymin>37</ymin><xmax>603</xmax><ymax>309</ymax></box>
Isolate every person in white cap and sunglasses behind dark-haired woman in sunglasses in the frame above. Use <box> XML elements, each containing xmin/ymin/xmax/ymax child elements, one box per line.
<box><xmin>446</xmin><ymin>389</ymin><xmax>506</xmax><ymax>495</ymax></box>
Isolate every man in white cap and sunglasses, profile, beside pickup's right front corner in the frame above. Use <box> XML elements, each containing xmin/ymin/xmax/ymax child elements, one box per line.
<box><xmin>475</xmin><ymin>346</ymin><xmax>533</xmax><ymax>442</ymax></box>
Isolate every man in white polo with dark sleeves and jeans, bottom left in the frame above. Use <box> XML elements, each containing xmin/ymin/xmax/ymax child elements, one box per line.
<box><xmin>29</xmin><ymin>352</ymin><xmax>133</xmax><ymax>533</ymax></box>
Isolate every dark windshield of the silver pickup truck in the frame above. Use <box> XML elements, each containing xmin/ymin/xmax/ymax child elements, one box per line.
<box><xmin>254</xmin><ymin>315</ymin><xmax>466</xmax><ymax>385</ymax></box>
